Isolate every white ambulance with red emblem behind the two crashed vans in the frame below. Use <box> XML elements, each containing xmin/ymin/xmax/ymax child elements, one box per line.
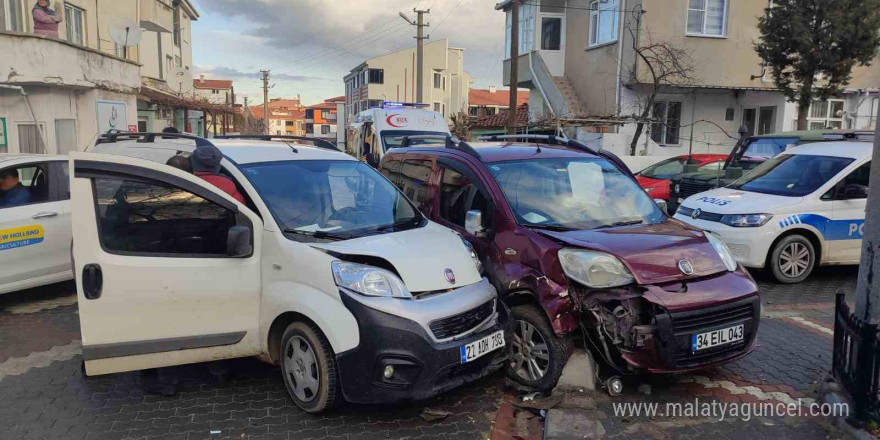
<box><xmin>346</xmin><ymin>102</ymin><xmax>450</xmax><ymax>167</ymax></box>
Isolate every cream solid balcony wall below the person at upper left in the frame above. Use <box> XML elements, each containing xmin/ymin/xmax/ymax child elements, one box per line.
<box><xmin>0</xmin><ymin>32</ymin><xmax>141</xmax><ymax>93</ymax></box>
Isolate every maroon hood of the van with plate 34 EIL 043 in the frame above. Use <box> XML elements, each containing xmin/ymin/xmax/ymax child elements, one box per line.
<box><xmin>538</xmin><ymin>220</ymin><xmax>727</xmax><ymax>284</ymax></box>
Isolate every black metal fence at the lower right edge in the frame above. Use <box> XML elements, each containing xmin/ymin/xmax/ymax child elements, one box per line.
<box><xmin>831</xmin><ymin>291</ymin><xmax>880</xmax><ymax>421</ymax></box>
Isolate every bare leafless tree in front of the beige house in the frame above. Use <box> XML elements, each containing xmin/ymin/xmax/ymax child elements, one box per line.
<box><xmin>626</xmin><ymin>17</ymin><xmax>696</xmax><ymax>156</ymax></box>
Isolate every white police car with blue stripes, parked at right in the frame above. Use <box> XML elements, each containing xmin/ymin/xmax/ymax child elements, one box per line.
<box><xmin>675</xmin><ymin>138</ymin><xmax>872</xmax><ymax>283</ymax></box>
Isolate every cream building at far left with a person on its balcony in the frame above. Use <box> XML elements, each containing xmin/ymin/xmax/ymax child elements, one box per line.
<box><xmin>0</xmin><ymin>0</ymin><xmax>142</xmax><ymax>154</ymax></box>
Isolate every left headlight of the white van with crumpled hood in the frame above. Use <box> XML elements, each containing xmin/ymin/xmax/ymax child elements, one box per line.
<box><xmin>330</xmin><ymin>261</ymin><xmax>412</xmax><ymax>298</ymax></box>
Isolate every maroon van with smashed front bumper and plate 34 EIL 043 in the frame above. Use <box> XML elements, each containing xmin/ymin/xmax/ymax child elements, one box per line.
<box><xmin>380</xmin><ymin>136</ymin><xmax>760</xmax><ymax>389</ymax></box>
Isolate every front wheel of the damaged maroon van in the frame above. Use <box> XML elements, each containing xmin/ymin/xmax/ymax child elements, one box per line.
<box><xmin>504</xmin><ymin>305</ymin><xmax>571</xmax><ymax>390</ymax></box>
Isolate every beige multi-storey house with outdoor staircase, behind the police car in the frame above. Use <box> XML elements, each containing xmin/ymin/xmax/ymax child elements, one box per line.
<box><xmin>496</xmin><ymin>0</ymin><xmax>880</xmax><ymax>155</ymax></box>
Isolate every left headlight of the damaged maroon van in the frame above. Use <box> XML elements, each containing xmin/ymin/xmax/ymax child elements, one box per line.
<box><xmin>559</xmin><ymin>249</ymin><xmax>633</xmax><ymax>288</ymax></box>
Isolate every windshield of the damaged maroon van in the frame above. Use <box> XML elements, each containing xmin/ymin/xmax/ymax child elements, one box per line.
<box><xmin>489</xmin><ymin>158</ymin><xmax>665</xmax><ymax>234</ymax></box>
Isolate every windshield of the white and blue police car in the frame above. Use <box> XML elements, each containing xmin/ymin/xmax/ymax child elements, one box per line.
<box><xmin>730</xmin><ymin>154</ymin><xmax>853</xmax><ymax>197</ymax></box>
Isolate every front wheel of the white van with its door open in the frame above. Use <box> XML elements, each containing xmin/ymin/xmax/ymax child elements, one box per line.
<box><xmin>279</xmin><ymin>322</ymin><xmax>339</xmax><ymax>413</ymax></box>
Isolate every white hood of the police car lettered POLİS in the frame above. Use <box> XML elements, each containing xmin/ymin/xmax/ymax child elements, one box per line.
<box><xmin>681</xmin><ymin>188</ymin><xmax>803</xmax><ymax>214</ymax></box>
